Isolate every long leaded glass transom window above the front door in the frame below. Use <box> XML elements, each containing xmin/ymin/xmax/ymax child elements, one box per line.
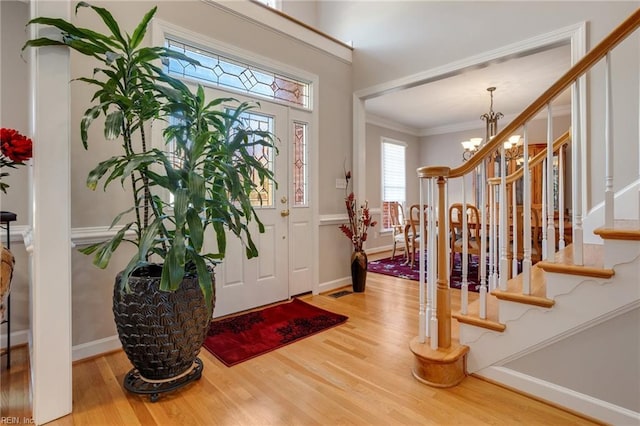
<box><xmin>164</xmin><ymin>39</ymin><xmax>311</xmax><ymax>109</ymax></box>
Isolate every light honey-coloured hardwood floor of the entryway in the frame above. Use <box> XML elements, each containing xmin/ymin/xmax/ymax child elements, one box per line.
<box><xmin>0</xmin><ymin>260</ymin><xmax>594</xmax><ymax>426</ymax></box>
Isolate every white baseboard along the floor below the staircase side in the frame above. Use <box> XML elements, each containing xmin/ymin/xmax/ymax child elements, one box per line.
<box><xmin>474</xmin><ymin>367</ymin><xmax>640</xmax><ymax>425</ymax></box>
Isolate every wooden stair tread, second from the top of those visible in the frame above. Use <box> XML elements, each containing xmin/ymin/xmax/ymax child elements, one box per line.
<box><xmin>536</xmin><ymin>244</ymin><xmax>614</xmax><ymax>278</ymax></box>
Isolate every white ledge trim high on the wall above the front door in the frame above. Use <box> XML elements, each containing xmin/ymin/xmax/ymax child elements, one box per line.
<box><xmin>202</xmin><ymin>0</ymin><xmax>353</xmax><ymax>64</ymax></box>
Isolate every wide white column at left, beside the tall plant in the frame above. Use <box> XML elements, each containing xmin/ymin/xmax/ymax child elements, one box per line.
<box><xmin>28</xmin><ymin>0</ymin><xmax>72</xmax><ymax>424</ymax></box>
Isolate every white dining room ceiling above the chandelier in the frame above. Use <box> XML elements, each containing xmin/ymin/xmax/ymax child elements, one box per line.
<box><xmin>365</xmin><ymin>44</ymin><xmax>571</xmax><ymax>136</ymax></box>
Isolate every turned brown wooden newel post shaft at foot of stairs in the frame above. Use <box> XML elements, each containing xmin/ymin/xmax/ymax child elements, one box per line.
<box><xmin>436</xmin><ymin>176</ymin><xmax>451</xmax><ymax>348</ymax></box>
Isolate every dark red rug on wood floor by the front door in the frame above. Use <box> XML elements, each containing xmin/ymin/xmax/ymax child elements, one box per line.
<box><xmin>204</xmin><ymin>299</ymin><xmax>348</xmax><ymax>367</ymax></box>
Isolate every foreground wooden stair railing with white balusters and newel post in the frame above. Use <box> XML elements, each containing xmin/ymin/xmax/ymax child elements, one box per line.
<box><xmin>410</xmin><ymin>9</ymin><xmax>640</xmax><ymax>387</ymax></box>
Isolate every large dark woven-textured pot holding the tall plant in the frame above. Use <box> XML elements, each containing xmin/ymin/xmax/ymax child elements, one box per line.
<box><xmin>113</xmin><ymin>265</ymin><xmax>215</xmax><ymax>380</ymax></box>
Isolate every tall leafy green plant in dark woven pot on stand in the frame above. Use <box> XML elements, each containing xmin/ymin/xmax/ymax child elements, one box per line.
<box><xmin>25</xmin><ymin>2</ymin><xmax>275</xmax><ymax>400</ymax></box>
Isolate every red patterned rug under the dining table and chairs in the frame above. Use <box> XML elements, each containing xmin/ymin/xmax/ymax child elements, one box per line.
<box><xmin>368</xmin><ymin>255</ymin><xmax>480</xmax><ymax>292</ymax></box>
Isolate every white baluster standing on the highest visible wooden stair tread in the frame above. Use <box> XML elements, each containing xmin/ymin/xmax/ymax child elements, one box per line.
<box><xmin>604</xmin><ymin>53</ymin><xmax>614</xmax><ymax>228</ymax></box>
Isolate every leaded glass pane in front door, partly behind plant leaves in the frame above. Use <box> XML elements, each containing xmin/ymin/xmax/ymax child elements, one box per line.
<box><xmin>232</xmin><ymin>112</ymin><xmax>275</xmax><ymax>207</ymax></box>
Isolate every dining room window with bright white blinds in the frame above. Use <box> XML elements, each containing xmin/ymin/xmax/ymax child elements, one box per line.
<box><xmin>381</xmin><ymin>138</ymin><xmax>407</xmax><ymax>229</ymax></box>
